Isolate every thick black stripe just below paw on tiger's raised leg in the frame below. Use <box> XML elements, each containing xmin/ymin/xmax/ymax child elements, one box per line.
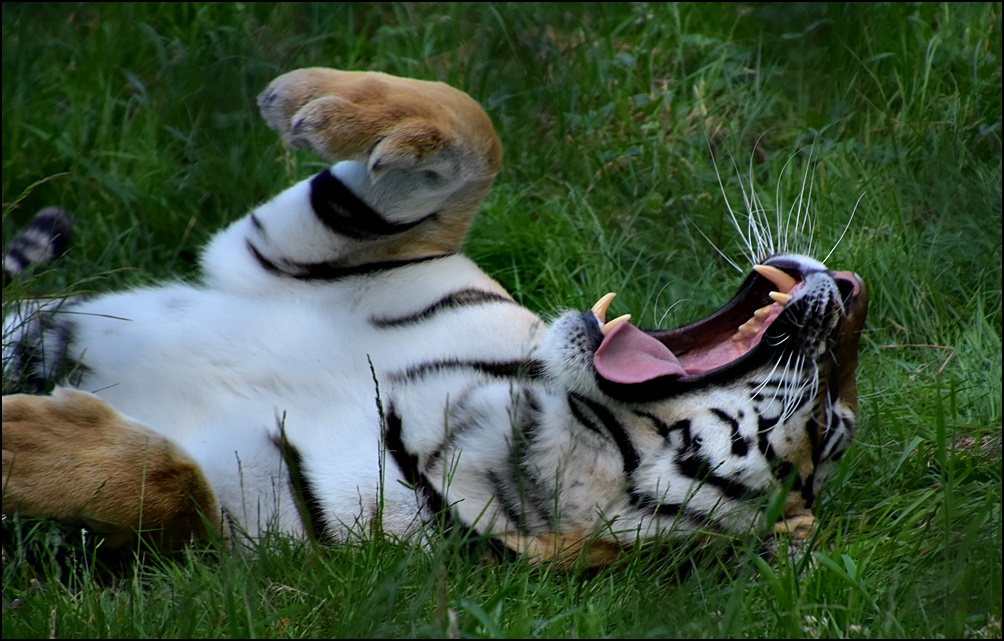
<box><xmin>310</xmin><ymin>169</ymin><xmax>436</xmax><ymax>240</ymax></box>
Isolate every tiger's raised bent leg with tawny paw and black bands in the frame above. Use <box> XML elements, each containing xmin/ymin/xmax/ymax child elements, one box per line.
<box><xmin>202</xmin><ymin>67</ymin><xmax>502</xmax><ymax>289</ymax></box>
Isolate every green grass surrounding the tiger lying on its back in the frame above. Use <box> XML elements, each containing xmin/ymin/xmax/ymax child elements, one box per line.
<box><xmin>2</xmin><ymin>3</ymin><xmax>1002</xmax><ymax>638</ymax></box>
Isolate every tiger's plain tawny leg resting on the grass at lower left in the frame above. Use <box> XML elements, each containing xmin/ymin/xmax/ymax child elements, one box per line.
<box><xmin>3</xmin><ymin>389</ymin><xmax>221</xmax><ymax>547</ymax></box>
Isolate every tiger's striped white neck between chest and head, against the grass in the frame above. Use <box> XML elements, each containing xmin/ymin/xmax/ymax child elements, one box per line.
<box><xmin>389</xmin><ymin>379</ymin><xmax>669</xmax><ymax>561</ymax></box>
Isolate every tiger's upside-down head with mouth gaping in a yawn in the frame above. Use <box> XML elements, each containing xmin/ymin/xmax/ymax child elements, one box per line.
<box><xmin>544</xmin><ymin>254</ymin><xmax>867</xmax><ymax>538</ymax></box>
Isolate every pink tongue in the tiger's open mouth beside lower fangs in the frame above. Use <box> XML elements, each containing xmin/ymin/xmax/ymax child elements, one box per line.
<box><xmin>592</xmin><ymin>323</ymin><xmax>687</xmax><ymax>383</ymax></box>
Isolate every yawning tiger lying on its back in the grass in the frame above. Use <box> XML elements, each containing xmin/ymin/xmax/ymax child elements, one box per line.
<box><xmin>3</xmin><ymin>67</ymin><xmax>867</xmax><ymax>567</ymax></box>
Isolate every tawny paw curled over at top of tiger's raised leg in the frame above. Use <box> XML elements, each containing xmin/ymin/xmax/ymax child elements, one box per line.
<box><xmin>258</xmin><ymin>67</ymin><xmax>501</xmax><ymax>182</ymax></box>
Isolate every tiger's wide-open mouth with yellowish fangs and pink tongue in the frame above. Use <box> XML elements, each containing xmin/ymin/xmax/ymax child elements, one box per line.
<box><xmin>586</xmin><ymin>256</ymin><xmax>866</xmax><ymax>386</ymax></box>
